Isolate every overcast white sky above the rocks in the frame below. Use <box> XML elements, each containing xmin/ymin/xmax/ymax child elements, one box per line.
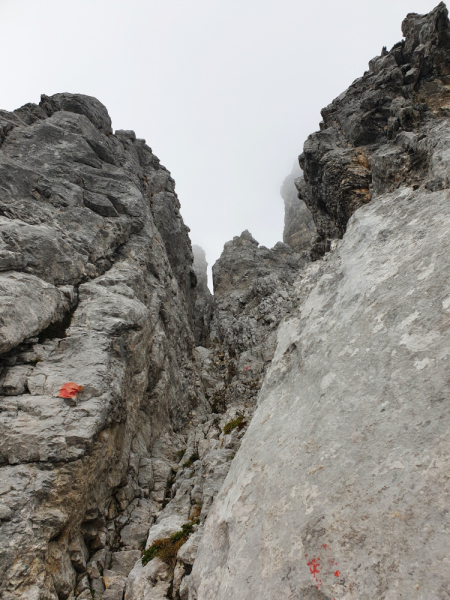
<box><xmin>0</xmin><ymin>0</ymin><xmax>438</xmax><ymax>284</ymax></box>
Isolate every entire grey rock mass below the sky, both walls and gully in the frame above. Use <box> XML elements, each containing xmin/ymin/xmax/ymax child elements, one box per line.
<box><xmin>0</xmin><ymin>3</ymin><xmax>450</xmax><ymax>600</ymax></box>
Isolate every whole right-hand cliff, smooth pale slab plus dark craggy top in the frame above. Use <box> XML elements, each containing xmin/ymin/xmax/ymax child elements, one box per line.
<box><xmin>189</xmin><ymin>3</ymin><xmax>450</xmax><ymax>600</ymax></box>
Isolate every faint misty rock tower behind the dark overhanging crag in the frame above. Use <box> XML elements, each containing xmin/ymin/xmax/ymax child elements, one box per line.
<box><xmin>280</xmin><ymin>166</ymin><xmax>316</xmax><ymax>253</ymax></box>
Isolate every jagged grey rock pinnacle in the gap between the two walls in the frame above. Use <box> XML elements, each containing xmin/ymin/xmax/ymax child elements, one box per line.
<box><xmin>210</xmin><ymin>231</ymin><xmax>309</xmax><ymax>386</ymax></box>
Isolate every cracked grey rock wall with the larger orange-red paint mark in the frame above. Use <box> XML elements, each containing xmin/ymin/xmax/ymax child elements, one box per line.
<box><xmin>0</xmin><ymin>94</ymin><xmax>207</xmax><ymax>600</ymax></box>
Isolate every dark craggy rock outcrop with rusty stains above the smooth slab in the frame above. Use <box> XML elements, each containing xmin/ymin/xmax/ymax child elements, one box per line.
<box><xmin>298</xmin><ymin>2</ymin><xmax>450</xmax><ymax>257</ymax></box>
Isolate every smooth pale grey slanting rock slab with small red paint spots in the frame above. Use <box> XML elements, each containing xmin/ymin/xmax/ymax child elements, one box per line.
<box><xmin>190</xmin><ymin>183</ymin><xmax>450</xmax><ymax>600</ymax></box>
